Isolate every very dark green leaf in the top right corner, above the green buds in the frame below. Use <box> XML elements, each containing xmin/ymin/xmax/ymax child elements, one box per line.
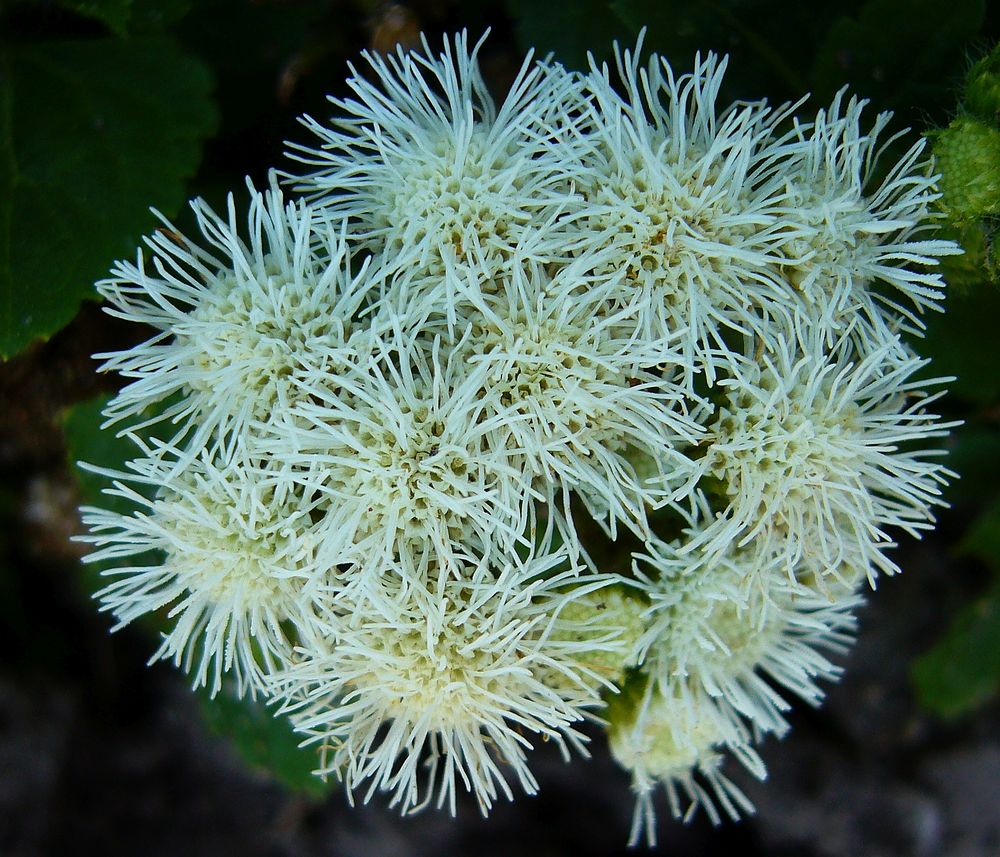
<box><xmin>812</xmin><ymin>0</ymin><xmax>985</xmax><ymax>121</ymax></box>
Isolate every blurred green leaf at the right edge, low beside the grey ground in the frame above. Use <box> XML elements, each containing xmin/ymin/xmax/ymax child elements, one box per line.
<box><xmin>912</xmin><ymin>586</ymin><xmax>1000</xmax><ymax>718</ymax></box>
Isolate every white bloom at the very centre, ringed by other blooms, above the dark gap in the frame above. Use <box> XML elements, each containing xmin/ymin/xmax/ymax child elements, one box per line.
<box><xmin>436</xmin><ymin>262</ymin><xmax>703</xmax><ymax>540</ymax></box>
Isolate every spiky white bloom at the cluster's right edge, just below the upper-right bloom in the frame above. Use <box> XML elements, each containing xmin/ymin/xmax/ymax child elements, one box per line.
<box><xmin>686</xmin><ymin>334</ymin><xmax>951</xmax><ymax>583</ymax></box>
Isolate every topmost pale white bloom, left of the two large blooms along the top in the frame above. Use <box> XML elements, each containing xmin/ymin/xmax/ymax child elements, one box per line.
<box><xmin>292</xmin><ymin>33</ymin><xmax>580</xmax><ymax>276</ymax></box>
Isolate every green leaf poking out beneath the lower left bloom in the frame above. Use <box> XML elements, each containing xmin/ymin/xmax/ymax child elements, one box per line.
<box><xmin>198</xmin><ymin>690</ymin><xmax>334</xmax><ymax>798</ymax></box>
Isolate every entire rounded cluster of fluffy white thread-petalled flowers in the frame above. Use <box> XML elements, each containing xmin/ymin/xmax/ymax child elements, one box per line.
<box><xmin>76</xmin><ymin>35</ymin><xmax>956</xmax><ymax>836</ymax></box>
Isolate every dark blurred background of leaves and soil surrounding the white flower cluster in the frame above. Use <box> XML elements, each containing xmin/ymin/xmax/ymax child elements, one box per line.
<box><xmin>0</xmin><ymin>0</ymin><xmax>1000</xmax><ymax>857</ymax></box>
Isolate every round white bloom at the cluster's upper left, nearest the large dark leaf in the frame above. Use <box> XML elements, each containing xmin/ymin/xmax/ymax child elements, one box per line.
<box><xmin>96</xmin><ymin>176</ymin><xmax>369</xmax><ymax>459</ymax></box>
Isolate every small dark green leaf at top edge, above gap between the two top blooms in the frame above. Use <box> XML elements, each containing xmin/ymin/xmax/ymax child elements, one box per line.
<box><xmin>507</xmin><ymin>0</ymin><xmax>635</xmax><ymax>70</ymax></box>
